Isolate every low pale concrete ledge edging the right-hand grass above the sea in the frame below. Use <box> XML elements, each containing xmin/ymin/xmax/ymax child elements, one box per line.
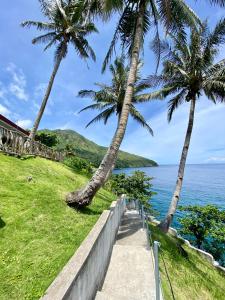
<box><xmin>151</xmin><ymin>217</ymin><xmax>225</xmax><ymax>273</ymax></box>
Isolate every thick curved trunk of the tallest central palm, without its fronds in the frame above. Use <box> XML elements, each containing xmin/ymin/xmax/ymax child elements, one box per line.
<box><xmin>66</xmin><ymin>0</ymin><xmax>145</xmax><ymax>206</ymax></box>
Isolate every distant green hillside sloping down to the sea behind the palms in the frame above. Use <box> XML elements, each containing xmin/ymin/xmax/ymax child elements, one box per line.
<box><xmin>48</xmin><ymin>130</ymin><xmax>157</xmax><ymax>168</ymax></box>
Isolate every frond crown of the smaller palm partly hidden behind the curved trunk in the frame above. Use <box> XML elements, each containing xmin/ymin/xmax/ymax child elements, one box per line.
<box><xmin>79</xmin><ymin>57</ymin><xmax>153</xmax><ymax>135</ymax></box>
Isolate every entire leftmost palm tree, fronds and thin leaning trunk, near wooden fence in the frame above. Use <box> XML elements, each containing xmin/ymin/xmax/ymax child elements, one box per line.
<box><xmin>22</xmin><ymin>0</ymin><xmax>97</xmax><ymax>141</ymax></box>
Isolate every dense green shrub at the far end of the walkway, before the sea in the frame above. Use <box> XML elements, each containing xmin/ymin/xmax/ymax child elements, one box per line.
<box><xmin>110</xmin><ymin>171</ymin><xmax>154</xmax><ymax>209</ymax></box>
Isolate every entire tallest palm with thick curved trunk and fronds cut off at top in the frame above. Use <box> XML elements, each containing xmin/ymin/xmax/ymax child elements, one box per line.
<box><xmin>66</xmin><ymin>0</ymin><xmax>198</xmax><ymax>206</ymax></box>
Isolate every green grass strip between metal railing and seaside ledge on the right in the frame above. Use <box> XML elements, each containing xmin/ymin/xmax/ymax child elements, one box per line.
<box><xmin>151</xmin><ymin>225</ymin><xmax>225</xmax><ymax>300</ymax></box>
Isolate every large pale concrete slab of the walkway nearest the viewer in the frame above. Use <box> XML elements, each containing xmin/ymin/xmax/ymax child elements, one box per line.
<box><xmin>102</xmin><ymin>244</ymin><xmax>155</xmax><ymax>300</ymax></box>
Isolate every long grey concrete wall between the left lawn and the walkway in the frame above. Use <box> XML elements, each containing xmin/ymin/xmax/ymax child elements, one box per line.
<box><xmin>42</xmin><ymin>197</ymin><xmax>125</xmax><ymax>300</ymax></box>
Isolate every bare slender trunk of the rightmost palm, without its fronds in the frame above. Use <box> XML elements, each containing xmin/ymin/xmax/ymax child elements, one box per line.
<box><xmin>159</xmin><ymin>98</ymin><xmax>196</xmax><ymax>232</ymax></box>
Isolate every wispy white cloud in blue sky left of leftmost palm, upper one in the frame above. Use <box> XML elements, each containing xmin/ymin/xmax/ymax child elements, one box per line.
<box><xmin>6</xmin><ymin>63</ymin><xmax>28</xmax><ymax>101</ymax></box>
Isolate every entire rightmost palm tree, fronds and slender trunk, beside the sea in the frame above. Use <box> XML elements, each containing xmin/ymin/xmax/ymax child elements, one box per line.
<box><xmin>144</xmin><ymin>19</ymin><xmax>225</xmax><ymax>232</ymax></box>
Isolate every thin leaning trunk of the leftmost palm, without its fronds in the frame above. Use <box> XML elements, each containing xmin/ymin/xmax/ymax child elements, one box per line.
<box><xmin>29</xmin><ymin>49</ymin><xmax>65</xmax><ymax>142</ymax></box>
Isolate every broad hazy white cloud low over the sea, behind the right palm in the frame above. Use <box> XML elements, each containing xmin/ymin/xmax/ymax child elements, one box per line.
<box><xmin>123</xmin><ymin>99</ymin><xmax>225</xmax><ymax>164</ymax></box>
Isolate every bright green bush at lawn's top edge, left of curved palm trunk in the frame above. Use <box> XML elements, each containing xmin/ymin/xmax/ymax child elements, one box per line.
<box><xmin>64</xmin><ymin>156</ymin><xmax>93</xmax><ymax>176</ymax></box>
